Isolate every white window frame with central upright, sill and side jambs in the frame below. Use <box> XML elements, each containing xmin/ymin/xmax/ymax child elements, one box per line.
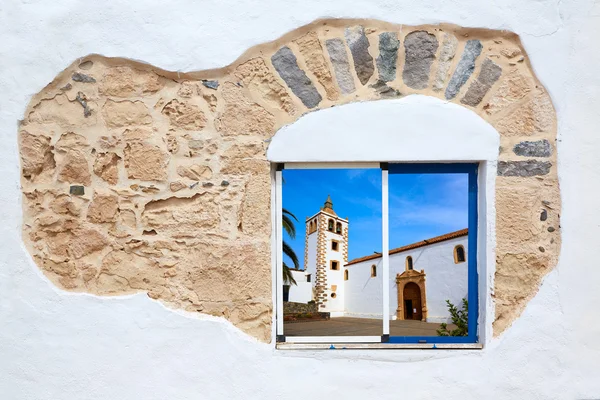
<box><xmin>271</xmin><ymin>160</ymin><xmax>486</xmax><ymax>350</ymax></box>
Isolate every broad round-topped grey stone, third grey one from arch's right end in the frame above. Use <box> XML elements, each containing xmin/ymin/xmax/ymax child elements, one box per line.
<box><xmin>402</xmin><ymin>31</ymin><xmax>439</xmax><ymax>89</ymax></box>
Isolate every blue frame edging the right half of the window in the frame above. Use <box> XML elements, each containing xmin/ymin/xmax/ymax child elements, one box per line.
<box><xmin>382</xmin><ymin>163</ymin><xmax>479</xmax><ymax>344</ymax></box>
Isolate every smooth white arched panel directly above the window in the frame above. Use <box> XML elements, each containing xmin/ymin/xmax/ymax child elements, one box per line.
<box><xmin>267</xmin><ymin>95</ymin><xmax>500</xmax><ymax>162</ymax></box>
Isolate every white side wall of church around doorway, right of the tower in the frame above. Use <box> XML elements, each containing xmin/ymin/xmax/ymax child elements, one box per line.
<box><xmin>344</xmin><ymin>236</ymin><xmax>468</xmax><ymax>322</ymax></box>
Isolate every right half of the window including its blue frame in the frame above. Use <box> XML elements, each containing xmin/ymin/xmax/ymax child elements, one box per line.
<box><xmin>388</xmin><ymin>164</ymin><xmax>478</xmax><ymax>343</ymax></box>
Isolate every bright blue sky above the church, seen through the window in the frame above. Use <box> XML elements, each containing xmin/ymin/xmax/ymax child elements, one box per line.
<box><xmin>283</xmin><ymin>169</ymin><xmax>468</xmax><ymax>268</ymax></box>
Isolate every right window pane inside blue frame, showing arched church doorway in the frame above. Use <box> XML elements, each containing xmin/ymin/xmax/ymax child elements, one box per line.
<box><xmin>389</xmin><ymin>173</ymin><xmax>469</xmax><ymax>336</ymax></box>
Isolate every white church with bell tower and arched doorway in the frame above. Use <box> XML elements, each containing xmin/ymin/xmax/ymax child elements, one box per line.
<box><xmin>288</xmin><ymin>197</ymin><xmax>468</xmax><ymax>323</ymax></box>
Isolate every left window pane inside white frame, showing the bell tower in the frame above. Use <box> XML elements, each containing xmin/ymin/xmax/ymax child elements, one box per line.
<box><xmin>282</xmin><ymin>169</ymin><xmax>383</xmax><ymax>336</ymax></box>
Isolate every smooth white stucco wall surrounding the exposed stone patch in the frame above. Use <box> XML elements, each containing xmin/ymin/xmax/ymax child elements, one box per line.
<box><xmin>0</xmin><ymin>0</ymin><xmax>600</xmax><ymax>400</ymax></box>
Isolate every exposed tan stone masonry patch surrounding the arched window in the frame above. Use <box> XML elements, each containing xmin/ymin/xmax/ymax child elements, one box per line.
<box><xmin>19</xmin><ymin>20</ymin><xmax>561</xmax><ymax>341</ymax></box>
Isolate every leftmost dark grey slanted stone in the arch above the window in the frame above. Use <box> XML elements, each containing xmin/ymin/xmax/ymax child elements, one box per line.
<box><xmin>271</xmin><ymin>46</ymin><xmax>322</xmax><ymax>108</ymax></box>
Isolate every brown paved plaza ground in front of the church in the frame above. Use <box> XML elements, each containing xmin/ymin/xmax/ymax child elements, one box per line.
<box><xmin>283</xmin><ymin>317</ymin><xmax>454</xmax><ymax>336</ymax></box>
